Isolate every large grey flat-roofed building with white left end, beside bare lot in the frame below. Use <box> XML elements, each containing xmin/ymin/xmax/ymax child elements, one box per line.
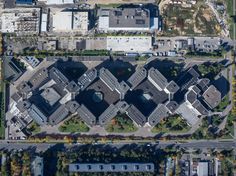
<box><xmin>98</xmin><ymin>8</ymin><xmax>159</xmax><ymax>32</ymax></box>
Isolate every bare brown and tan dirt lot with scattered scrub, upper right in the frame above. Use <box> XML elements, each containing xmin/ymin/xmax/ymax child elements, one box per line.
<box><xmin>163</xmin><ymin>1</ymin><xmax>220</xmax><ymax>36</ymax></box>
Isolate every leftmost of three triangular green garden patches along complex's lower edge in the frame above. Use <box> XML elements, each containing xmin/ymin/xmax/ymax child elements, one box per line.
<box><xmin>59</xmin><ymin>116</ymin><xmax>89</xmax><ymax>133</ymax></box>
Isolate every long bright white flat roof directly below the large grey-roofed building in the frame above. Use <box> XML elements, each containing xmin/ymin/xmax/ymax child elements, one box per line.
<box><xmin>107</xmin><ymin>36</ymin><xmax>152</xmax><ymax>53</ymax></box>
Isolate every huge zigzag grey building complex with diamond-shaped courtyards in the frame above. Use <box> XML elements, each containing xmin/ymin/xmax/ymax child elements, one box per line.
<box><xmin>9</xmin><ymin>62</ymin><xmax>221</xmax><ymax>134</ymax></box>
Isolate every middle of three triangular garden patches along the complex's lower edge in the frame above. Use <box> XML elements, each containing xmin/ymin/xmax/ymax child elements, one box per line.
<box><xmin>105</xmin><ymin>114</ymin><xmax>138</xmax><ymax>133</ymax></box>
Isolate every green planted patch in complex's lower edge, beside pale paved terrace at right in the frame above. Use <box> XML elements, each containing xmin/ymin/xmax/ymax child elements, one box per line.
<box><xmin>152</xmin><ymin>115</ymin><xmax>190</xmax><ymax>133</ymax></box>
